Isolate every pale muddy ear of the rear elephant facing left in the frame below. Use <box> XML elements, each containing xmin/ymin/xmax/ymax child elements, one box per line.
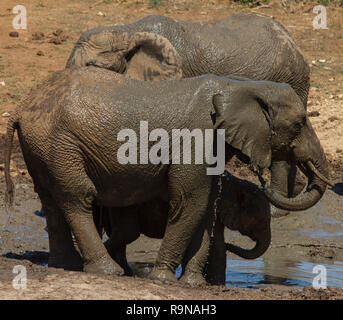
<box><xmin>125</xmin><ymin>32</ymin><xmax>182</xmax><ymax>81</ymax></box>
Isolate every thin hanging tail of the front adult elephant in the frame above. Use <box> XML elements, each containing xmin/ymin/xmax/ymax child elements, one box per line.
<box><xmin>5</xmin><ymin>112</ymin><xmax>19</xmax><ymax>209</ymax></box>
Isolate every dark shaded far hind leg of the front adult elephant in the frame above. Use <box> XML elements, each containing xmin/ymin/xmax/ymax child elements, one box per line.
<box><xmin>42</xmin><ymin>198</ymin><xmax>83</xmax><ymax>271</ymax></box>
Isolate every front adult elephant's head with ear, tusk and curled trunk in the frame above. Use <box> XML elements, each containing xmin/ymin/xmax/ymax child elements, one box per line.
<box><xmin>212</xmin><ymin>79</ymin><xmax>330</xmax><ymax>211</ymax></box>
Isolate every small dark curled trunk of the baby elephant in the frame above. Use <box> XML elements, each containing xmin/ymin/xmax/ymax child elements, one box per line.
<box><xmin>226</xmin><ymin>227</ymin><xmax>271</xmax><ymax>259</ymax></box>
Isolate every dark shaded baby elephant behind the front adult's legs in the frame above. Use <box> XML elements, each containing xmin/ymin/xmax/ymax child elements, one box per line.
<box><xmin>97</xmin><ymin>172</ymin><xmax>271</xmax><ymax>284</ymax></box>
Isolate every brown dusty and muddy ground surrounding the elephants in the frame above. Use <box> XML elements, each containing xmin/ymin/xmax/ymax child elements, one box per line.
<box><xmin>0</xmin><ymin>0</ymin><xmax>343</xmax><ymax>299</ymax></box>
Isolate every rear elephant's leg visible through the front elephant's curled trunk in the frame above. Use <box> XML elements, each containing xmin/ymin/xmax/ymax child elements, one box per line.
<box><xmin>270</xmin><ymin>161</ymin><xmax>306</xmax><ymax>217</ymax></box>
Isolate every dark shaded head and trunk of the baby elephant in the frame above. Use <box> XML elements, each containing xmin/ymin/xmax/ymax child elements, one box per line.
<box><xmin>217</xmin><ymin>172</ymin><xmax>271</xmax><ymax>259</ymax></box>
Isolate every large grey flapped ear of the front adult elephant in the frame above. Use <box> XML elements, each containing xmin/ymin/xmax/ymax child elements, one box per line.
<box><xmin>213</xmin><ymin>80</ymin><xmax>277</xmax><ymax>169</ymax></box>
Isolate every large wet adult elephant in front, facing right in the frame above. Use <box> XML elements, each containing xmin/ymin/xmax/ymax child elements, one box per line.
<box><xmin>5</xmin><ymin>67</ymin><xmax>328</xmax><ymax>283</ymax></box>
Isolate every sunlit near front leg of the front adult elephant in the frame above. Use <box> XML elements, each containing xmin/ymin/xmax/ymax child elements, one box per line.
<box><xmin>150</xmin><ymin>166</ymin><xmax>212</xmax><ymax>284</ymax></box>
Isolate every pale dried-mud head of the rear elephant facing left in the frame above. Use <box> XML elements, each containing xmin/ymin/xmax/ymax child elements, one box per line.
<box><xmin>66</xmin><ymin>29</ymin><xmax>182</xmax><ymax>81</ymax></box>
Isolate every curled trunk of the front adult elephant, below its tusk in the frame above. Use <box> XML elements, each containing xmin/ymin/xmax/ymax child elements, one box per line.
<box><xmin>264</xmin><ymin>152</ymin><xmax>331</xmax><ymax>211</ymax></box>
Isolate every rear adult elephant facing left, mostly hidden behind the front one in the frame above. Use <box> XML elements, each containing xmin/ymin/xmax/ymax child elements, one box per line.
<box><xmin>67</xmin><ymin>14</ymin><xmax>310</xmax><ymax>216</ymax></box>
